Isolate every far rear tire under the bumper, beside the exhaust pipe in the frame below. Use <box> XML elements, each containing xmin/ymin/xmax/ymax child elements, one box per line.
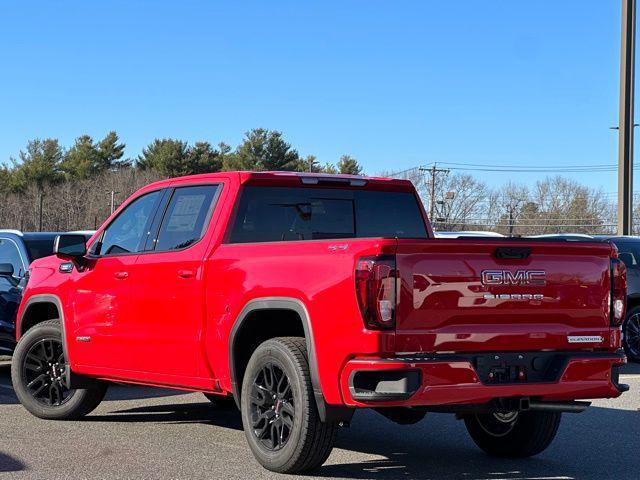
<box><xmin>464</xmin><ymin>412</ymin><xmax>561</xmax><ymax>458</ymax></box>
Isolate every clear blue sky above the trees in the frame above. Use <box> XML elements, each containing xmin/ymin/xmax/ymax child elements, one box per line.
<box><xmin>0</xmin><ymin>0</ymin><xmax>632</xmax><ymax>192</ymax></box>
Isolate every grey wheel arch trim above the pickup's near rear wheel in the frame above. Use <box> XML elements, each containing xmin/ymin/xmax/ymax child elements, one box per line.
<box><xmin>229</xmin><ymin>297</ymin><xmax>326</xmax><ymax>419</ymax></box>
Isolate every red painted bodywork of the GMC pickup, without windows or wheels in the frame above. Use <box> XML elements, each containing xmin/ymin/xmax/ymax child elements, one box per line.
<box><xmin>17</xmin><ymin>172</ymin><xmax>620</xmax><ymax>407</ymax></box>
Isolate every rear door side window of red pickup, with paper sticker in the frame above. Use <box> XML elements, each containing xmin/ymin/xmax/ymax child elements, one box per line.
<box><xmin>155</xmin><ymin>185</ymin><xmax>218</xmax><ymax>251</ymax></box>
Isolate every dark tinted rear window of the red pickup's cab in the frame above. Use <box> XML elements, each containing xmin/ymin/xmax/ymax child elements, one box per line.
<box><xmin>228</xmin><ymin>186</ymin><xmax>427</xmax><ymax>243</ymax></box>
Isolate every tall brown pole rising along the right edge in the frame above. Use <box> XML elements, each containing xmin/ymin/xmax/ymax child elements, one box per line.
<box><xmin>618</xmin><ymin>0</ymin><xmax>636</xmax><ymax>235</ymax></box>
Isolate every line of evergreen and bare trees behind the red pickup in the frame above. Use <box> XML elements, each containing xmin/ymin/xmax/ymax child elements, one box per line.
<box><xmin>0</xmin><ymin>128</ymin><xmax>624</xmax><ymax>235</ymax></box>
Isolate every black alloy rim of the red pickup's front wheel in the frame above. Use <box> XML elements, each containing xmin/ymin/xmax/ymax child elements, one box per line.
<box><xmin>23</xmin><ymin>338</ymin><xmax>74</xmax><ymax>407</ymax></box>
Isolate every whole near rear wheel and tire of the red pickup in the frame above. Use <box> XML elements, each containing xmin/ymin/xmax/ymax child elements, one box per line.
<box><xmin>241</xmin><ymin>337</ymin><xmax>338</xmax><ymax>473</ymax></box>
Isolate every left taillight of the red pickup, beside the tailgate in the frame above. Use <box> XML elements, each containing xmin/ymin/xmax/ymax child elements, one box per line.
<box><xmin>355</xmin><ymin>256</ymin><xmax>397</xmax><ymax>330</ymax></box>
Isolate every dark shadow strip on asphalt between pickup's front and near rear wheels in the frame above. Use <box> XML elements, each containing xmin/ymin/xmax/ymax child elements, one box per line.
<box><xmin>83</xmin><ymin>402</ymin><xmax>242</xmax><ymax>430</ymax></box>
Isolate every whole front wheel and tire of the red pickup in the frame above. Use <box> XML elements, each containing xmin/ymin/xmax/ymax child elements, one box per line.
<box><xmin>11</xmin><ymin>320</ymin><xmax>107</xmax><ymax>420</ymax></box>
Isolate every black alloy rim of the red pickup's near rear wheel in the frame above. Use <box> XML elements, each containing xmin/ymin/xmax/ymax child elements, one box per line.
<box><xmin>249</xmin><ymin>362</ymin><xmax>296</xmax><ymax>451</ymax></box>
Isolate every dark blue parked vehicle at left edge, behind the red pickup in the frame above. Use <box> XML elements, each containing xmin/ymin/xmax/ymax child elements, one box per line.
<box><xmin>0</xmin><ymin>230</ymin><xmax>91</xmax><ymax>355</ymax></box>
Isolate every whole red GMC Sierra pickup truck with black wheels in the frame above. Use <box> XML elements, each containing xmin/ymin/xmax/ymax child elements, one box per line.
<box><xmin>12</xmin><ymin>172</ymin><xmax>627</xmax><ymax>472</ymax></box>
